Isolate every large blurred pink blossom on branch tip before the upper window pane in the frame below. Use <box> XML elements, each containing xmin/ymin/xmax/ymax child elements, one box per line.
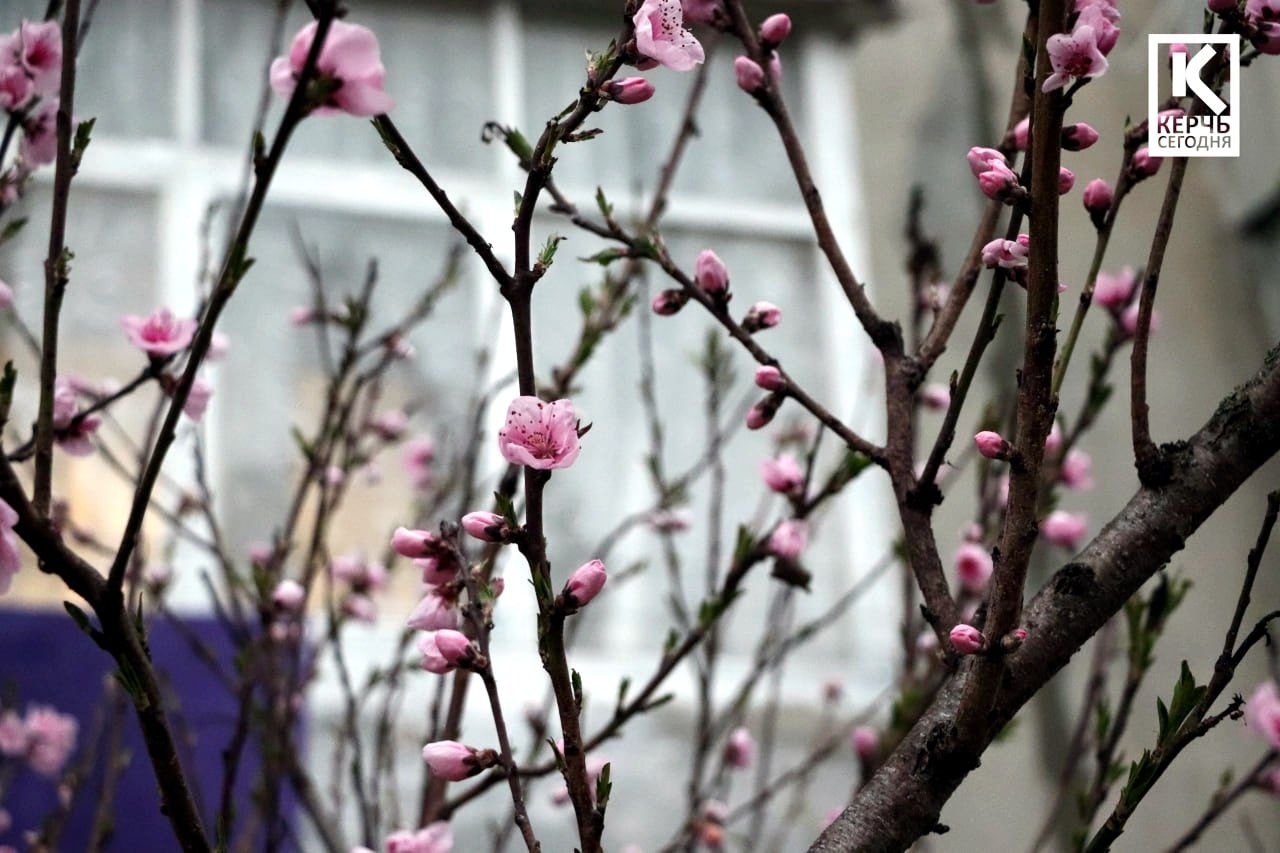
<box><xmin>271</xmin><ymin>20</ymin><xmax>394</xmax><ymax>115</ymax></box>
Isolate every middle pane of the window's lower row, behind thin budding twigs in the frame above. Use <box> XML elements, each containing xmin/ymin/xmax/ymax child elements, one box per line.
<box><xmin>216</xmin><ymin>206</ymin><xmax>479</xmax><ymax>549</ymax></box>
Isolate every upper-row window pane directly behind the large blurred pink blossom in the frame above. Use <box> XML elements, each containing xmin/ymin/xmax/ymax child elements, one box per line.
<box><xmin>202</xmin><ymin>0</ymin><xmax>494</xmax><ymax>169</ymax></box>
